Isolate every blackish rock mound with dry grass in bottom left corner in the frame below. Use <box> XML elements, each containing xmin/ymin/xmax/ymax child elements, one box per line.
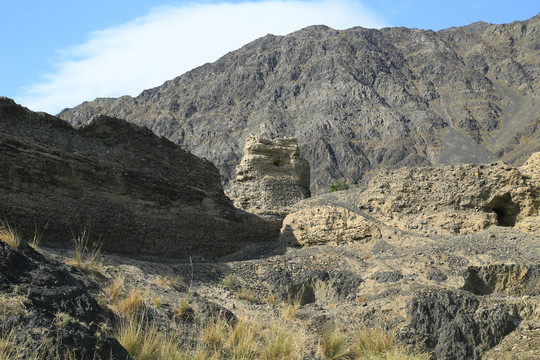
<box><xmin>0</xmin><ymin>242</ymin><xmax>128</xmax><ymax>360</ymax></box>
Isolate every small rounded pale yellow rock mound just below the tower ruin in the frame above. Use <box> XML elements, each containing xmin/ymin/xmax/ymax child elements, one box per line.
<box><xmin>280</xmin><ymin>206</ymin><xmax>380</xmax><ymax>246</ymax></box>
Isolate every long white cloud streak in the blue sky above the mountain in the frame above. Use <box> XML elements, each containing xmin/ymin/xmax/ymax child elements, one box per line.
<box><xmin>16</xmin><ymin>0</ymin><xmax>385</xmax><ymax>114</ymax></box>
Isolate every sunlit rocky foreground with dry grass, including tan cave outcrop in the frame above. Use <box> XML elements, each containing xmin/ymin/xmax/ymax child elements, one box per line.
<box><xmin>0</xmin><ymin>153</ymin><xmax>540</xmax><ymax>360</ymax></box>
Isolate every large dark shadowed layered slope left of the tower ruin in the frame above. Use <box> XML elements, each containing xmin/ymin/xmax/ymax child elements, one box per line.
<box><xmin>0</xmin><ymin>98</ymin><xmax>275</xmax><ymax>257</ymax></box>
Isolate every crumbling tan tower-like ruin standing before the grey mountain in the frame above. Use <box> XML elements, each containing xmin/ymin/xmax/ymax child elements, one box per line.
<box><xmin>227</xmin><ymin>135</ymin><xmax>311</xmax><ymax>226</ymax></box>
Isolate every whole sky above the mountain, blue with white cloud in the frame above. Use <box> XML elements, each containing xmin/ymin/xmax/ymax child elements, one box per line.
<box><xmin>0</xmin><ymin>0</ymin><xmax>540</xmax><ymax>114</ymax></box>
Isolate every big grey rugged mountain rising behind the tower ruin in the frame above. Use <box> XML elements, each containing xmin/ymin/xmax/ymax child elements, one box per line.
<box><xmin>59</xmin><ymin>16</ymin><xmax>540</xmax><ymax>193</ymax></box>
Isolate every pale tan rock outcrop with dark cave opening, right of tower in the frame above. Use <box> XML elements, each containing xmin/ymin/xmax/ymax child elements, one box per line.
<box><xmin>281</xmin><ymin>153</ymin><xmax>540</xmax><ymax>245</ymax></box>
